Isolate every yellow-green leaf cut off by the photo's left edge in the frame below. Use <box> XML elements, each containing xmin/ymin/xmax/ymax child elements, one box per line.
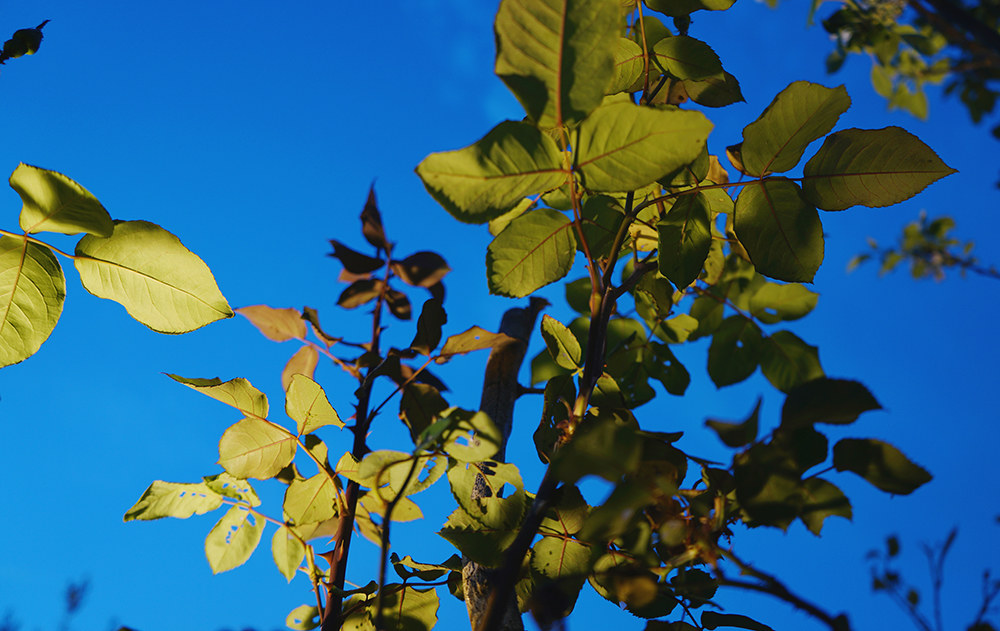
<box><xmin>0</xmin><ymin>237</ymin><xmax>66</xmax><ymax>367</ymax></box>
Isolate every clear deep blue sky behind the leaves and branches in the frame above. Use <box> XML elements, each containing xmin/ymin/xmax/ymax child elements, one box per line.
<box><xmin>0</xmin><ymin>0</ymin><xmax>1000</xmax><ymax>631</ymax></box>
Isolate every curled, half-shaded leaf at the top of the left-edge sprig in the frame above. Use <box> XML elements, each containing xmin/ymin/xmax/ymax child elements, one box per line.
<box><xmin>10</xmin><ymin>162</ymin><xmax>112</xmax><ymax>237</ymax></box>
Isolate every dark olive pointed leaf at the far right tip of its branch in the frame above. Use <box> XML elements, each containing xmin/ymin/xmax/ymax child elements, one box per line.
<box><xmin>802</xmin><ymin>127</ymin><xmax>957</xmax><ymax>210</ymax></box>
